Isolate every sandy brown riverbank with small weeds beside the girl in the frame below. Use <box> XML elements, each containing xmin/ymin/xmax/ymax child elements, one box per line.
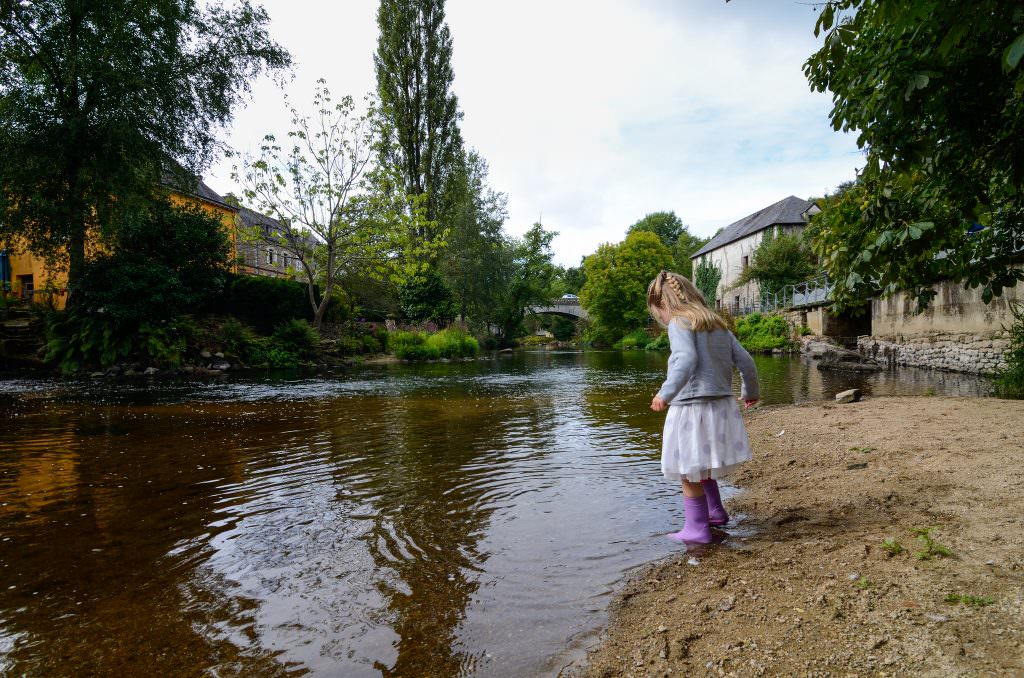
<box><xmin>581</xmin><ymin>397</ymin><xmax>1024</xmax><ymax>677</ymax></box>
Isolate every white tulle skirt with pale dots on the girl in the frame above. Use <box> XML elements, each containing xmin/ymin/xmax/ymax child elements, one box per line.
<box><xmin>662</xmin><ymin>396</ymin><xmax>751</xmax><ymax>482</ymax></box>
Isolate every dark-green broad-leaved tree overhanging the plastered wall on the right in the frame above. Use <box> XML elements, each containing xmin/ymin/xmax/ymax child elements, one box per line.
<box><xmin>805</xmin><ymin>0</ymin><xmax>1024</xmax><ymax>307</ymax></box>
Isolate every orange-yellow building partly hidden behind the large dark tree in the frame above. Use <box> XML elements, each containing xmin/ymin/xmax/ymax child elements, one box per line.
<box><xmin>0</xmin><ymin>176</ymin><xmax>239</xmax><ymax>308</ymax></box>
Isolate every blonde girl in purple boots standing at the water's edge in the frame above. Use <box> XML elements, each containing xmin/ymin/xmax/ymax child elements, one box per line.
<box><xmin>647</xmin><ymin>270</ymin><xmax>760</xmax><ymax>544</ymax></box>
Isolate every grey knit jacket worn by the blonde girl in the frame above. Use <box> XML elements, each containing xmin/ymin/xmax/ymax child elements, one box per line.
<box><xmin>657</xmin><ymin>317</ymin><xmax>761</xmax><ymax>405</ymax></box>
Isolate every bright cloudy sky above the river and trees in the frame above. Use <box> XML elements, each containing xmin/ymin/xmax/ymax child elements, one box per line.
<box><xmin>206</xmin><ymin>0</ymin><xmax>863</xmax><ymax>265</ymax></box>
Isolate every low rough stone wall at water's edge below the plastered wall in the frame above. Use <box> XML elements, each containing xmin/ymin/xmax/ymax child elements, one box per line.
<box><xmin>857</xmin><ymin>331</ymin><xmax>1010</xmax><ymax>374</ymax></box>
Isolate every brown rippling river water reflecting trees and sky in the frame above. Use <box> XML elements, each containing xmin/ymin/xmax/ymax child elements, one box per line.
<box><xmin>0</xmin><ymin>351</ymin><xmax>987</xmax><ymax>677</ymax></box>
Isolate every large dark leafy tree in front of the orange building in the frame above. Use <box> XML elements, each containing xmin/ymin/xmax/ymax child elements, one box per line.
<box><xmin>0</xmin><ymin>0</ymin><xmax>290</xmax><ymax>305</ymax></box>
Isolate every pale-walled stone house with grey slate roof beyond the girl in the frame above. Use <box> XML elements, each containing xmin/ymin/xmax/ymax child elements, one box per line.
<box><xmin>691</xmin><ymin>196</ymin><xmax>821</xmax><ymax>314</ymax></box>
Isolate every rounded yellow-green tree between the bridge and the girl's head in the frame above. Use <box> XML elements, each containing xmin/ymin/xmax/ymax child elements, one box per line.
<box><xmin>580</xmin><ymin>230</ymin><xmax>672</xmax><ymax>340</ymax></box>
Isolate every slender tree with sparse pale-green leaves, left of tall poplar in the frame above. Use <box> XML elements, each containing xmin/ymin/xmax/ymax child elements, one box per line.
<box><xmin>232</xmin><ymin>80</ymin><xmax>440</xmax><ymax>328</ymax></box>
